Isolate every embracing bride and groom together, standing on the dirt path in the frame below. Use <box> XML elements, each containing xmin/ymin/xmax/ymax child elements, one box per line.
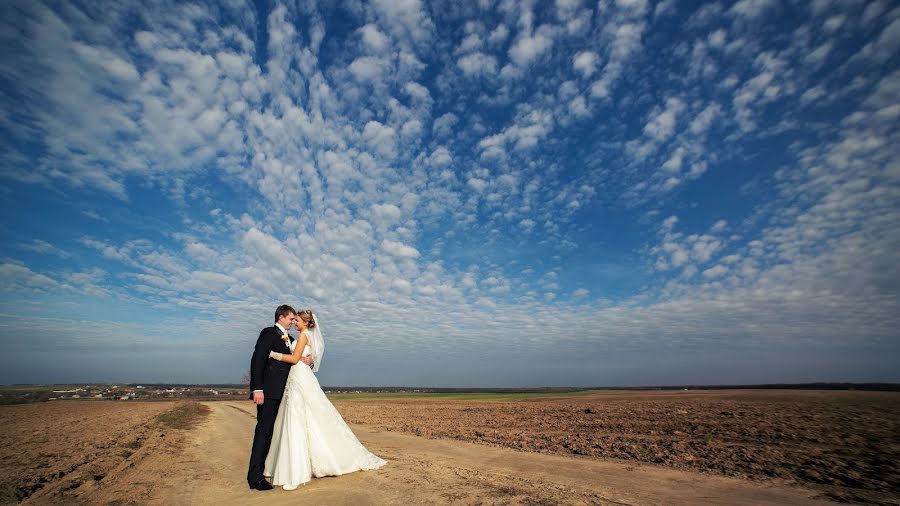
<box><xmin>247</xmin><ymin>305</ymin><xmax>386</xmax><ymax>490</ymax></box>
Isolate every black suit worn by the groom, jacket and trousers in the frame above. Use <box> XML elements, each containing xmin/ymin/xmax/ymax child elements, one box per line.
<box><xmin>247</xmin><ymin>326</ymin><xmax>293</xmax><ymax>485</ymax></box>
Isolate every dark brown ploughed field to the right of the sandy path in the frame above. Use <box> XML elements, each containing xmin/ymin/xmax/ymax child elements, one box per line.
<box><xmin>335</xmin><ymin>391</ymin><xmax>900</xmax><ymax>504</ymax></box>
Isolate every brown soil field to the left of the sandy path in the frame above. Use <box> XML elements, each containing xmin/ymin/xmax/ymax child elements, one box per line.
<box><xmin>0</xmin><ymin>401</ymin><xmax>207</xmax><ymax>504</ymax></box>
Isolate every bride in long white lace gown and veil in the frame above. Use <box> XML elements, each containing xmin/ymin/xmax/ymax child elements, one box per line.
<box><xmin>265</xmin><ymin>309</ymin><xmax>386</xmax><ymax>490</ymax></box>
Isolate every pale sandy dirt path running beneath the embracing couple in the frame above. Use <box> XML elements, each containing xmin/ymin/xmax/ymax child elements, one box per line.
<box><xmin>153</xmin><ymin>402</ymin><xmax>828</xmax><ymax>505</ymax></box>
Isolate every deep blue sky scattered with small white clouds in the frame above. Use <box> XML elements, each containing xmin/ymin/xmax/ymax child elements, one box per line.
<box><xmin>0</xmin><ymin>0</ymin><xmax>900</xmax><ymax>387</ymax></box>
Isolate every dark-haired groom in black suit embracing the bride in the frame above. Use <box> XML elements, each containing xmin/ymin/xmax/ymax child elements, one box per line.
<box><xmin>247</xmin><ymin>304</ymin><xmax>312</xmax><ymax>490</ymax></box>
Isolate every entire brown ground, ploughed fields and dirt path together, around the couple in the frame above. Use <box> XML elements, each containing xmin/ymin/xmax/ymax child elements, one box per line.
<box><xmin>0</xmin><ymin>391</ymin><xmax>900</xmax><ymax>506</ymax></box>
